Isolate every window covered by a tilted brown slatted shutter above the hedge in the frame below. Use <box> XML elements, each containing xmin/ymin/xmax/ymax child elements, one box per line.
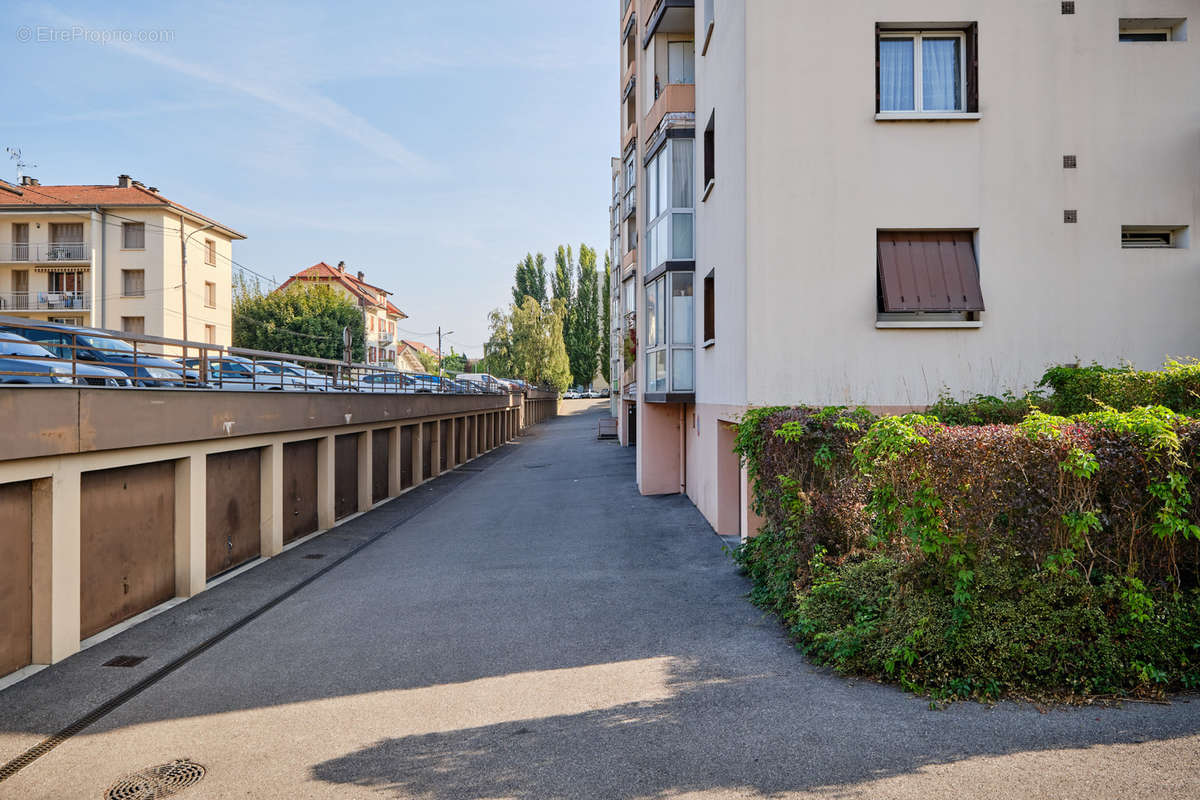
<box><xmin>876</xmin><ymin>230</ymin><xmax>984</xmax><ymax>327</ymax></box>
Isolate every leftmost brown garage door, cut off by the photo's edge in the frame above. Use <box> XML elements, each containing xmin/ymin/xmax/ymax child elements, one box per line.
<box><xmin>0</xmin><ymin>481</ymin><xmax>34</xmax><ymax>675</ymax></box>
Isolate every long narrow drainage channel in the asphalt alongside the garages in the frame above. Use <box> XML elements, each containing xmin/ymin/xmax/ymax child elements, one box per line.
<box><xmin>0</xmin><ymin>449</ymin><xmax>506</xmax><ymax>783</ymax></box>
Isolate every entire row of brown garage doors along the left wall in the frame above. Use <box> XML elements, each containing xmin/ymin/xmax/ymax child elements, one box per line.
<box><xmin>0</xmin><ymin>420</ymin><xmax>466</xmax><ymax>675</ymax></box>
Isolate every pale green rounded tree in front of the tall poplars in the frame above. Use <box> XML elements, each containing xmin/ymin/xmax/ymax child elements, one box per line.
<box><xmin>484</xmin><ymin>295</ymin><xmax>571</xmax><ymax>391</ymax></box>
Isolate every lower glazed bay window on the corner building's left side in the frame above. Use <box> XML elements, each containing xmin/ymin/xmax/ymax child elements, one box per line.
<box><xmin>646</xmin><ymin>271</ymin><xmax>696</xmax><ymax>393</ymax></box>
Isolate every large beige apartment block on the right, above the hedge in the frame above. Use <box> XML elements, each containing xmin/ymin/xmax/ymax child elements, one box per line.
<box><xmin>612</xmin><ymin>0</ymin><xmax>1200</xmax><ymax>535</ymax></box>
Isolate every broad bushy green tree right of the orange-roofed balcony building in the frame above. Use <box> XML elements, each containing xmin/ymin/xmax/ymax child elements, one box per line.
<box><xmin>233</xmin><ymin>279</ymin><xmax>366</xmax><ymax>362</ymax></box>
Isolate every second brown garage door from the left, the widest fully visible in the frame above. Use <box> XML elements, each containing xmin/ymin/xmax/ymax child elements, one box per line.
<box><xmin>79</xmin><ymin>461</ymin><xmax>175</xmax><ymax>638</ymax></box>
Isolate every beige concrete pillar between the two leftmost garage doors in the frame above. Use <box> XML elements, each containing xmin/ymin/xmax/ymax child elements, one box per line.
<box><xmin>32</xmin><ymin>467</ymin><xmax>80</xmax><ymax>664</ymax></box>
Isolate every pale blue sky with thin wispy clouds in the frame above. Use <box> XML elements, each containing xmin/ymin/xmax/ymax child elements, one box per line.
<box><xmin>0</xmin><ymin>0</ymin><xmax>619</xmax><ymax>355</ymax></box>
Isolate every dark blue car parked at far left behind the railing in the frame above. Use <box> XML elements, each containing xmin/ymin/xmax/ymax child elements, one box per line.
<box><xmin>0</xmin><ymin>321</ymin><xmax>185</xmax><ymax>386</ymax></box>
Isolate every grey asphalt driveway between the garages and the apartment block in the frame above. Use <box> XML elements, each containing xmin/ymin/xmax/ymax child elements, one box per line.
<box><xmin>0</xmin><ymin>402</ymin><xmax>1200</xmax><ymax>800</ymax></box>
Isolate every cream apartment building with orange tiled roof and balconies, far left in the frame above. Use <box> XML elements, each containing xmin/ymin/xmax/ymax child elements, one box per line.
<box><xmin>0</xmin><ymin>175</ymin><xmax>245</xmax><ymax>344</ymax></box>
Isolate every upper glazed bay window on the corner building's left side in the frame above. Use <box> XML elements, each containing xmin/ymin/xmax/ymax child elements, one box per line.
<box><xmin>644</xmin><ymin>139</ymin><xmax>696</xmax><ymax>271</ymax></box>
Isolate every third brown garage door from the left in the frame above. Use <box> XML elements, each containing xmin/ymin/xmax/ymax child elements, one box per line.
<box><xmin>205</xmin><ymin>450</ymin><xmax>262</xmax><ymax>578</ymax></box>
